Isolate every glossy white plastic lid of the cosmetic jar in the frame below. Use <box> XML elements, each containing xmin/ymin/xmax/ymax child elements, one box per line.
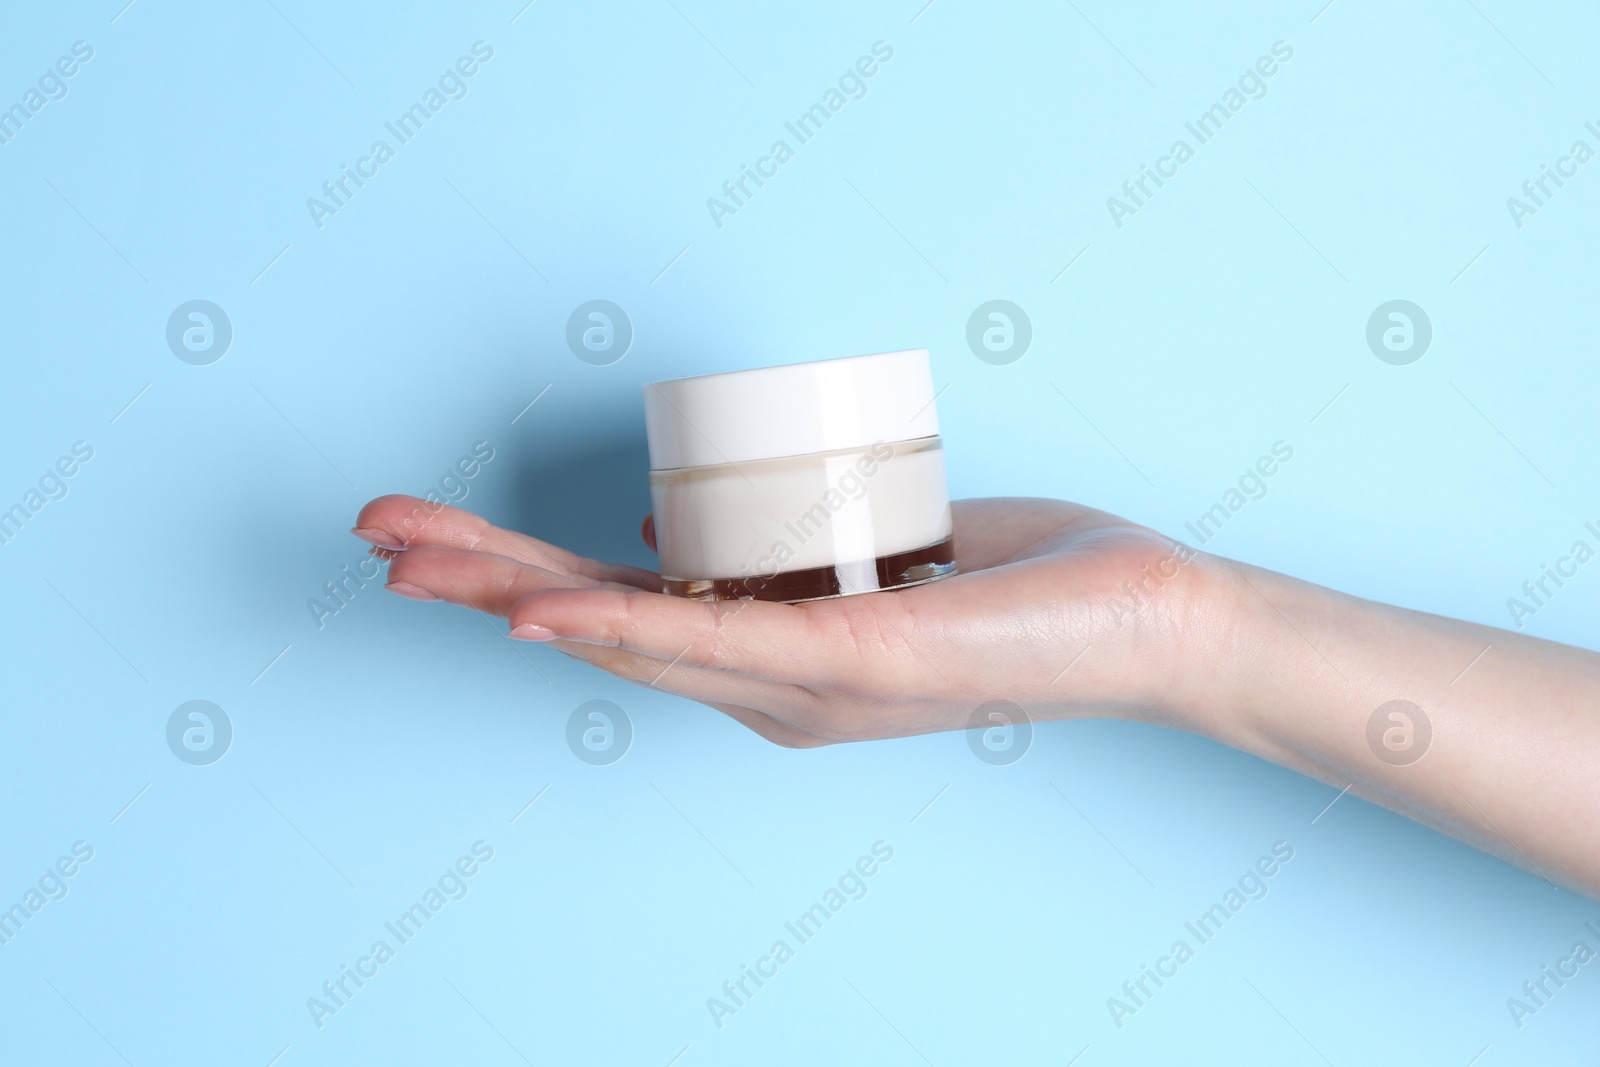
<box><xmin>645</xmin><ymin>349</ymin><xmax>939</xmax><ymax>470</ymax></box>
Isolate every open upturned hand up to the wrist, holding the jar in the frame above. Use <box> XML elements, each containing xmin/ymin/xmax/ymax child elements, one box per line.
<box><xmin>355</xmin><ymin>496</ymin><xmax>1214</xmax><ymax>747</ymax></box>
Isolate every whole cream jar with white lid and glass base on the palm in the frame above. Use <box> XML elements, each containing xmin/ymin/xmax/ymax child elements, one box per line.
<box><xmin>645</xmin><ymin>349</ymin><xmax>955</xmax><ymax>603</ymax></box>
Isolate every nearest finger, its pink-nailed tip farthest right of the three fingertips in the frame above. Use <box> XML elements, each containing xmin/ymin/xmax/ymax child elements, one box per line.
<box><xmin>510</xmin><ymin>587</ymin><xmax>845</xmax><ymax>680</ymax></box>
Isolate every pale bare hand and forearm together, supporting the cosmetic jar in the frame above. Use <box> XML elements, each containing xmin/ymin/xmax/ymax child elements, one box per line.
<box><xmin>355</xmin><ymin>496</ymin><xmax>1600</xmax><ymax>897</ymax></box>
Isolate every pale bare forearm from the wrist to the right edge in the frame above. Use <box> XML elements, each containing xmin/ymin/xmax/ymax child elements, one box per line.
<box><xmin>1174</xmin><ymin>560</ymin><xmax>1600</xmax><ymax>896</ymax></box>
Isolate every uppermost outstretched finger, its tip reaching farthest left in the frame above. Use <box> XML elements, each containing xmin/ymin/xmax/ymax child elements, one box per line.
<box><xmin>352</xmin><ymin>494</ymin><xmax>661</xmax><ymax>590</ymax></box>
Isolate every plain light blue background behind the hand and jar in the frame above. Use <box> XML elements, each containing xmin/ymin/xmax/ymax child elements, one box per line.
<box><xmin>0</xmin><ymin>0</ymin><xmax>1600</xmax><ymax>1067</ymax></box>
